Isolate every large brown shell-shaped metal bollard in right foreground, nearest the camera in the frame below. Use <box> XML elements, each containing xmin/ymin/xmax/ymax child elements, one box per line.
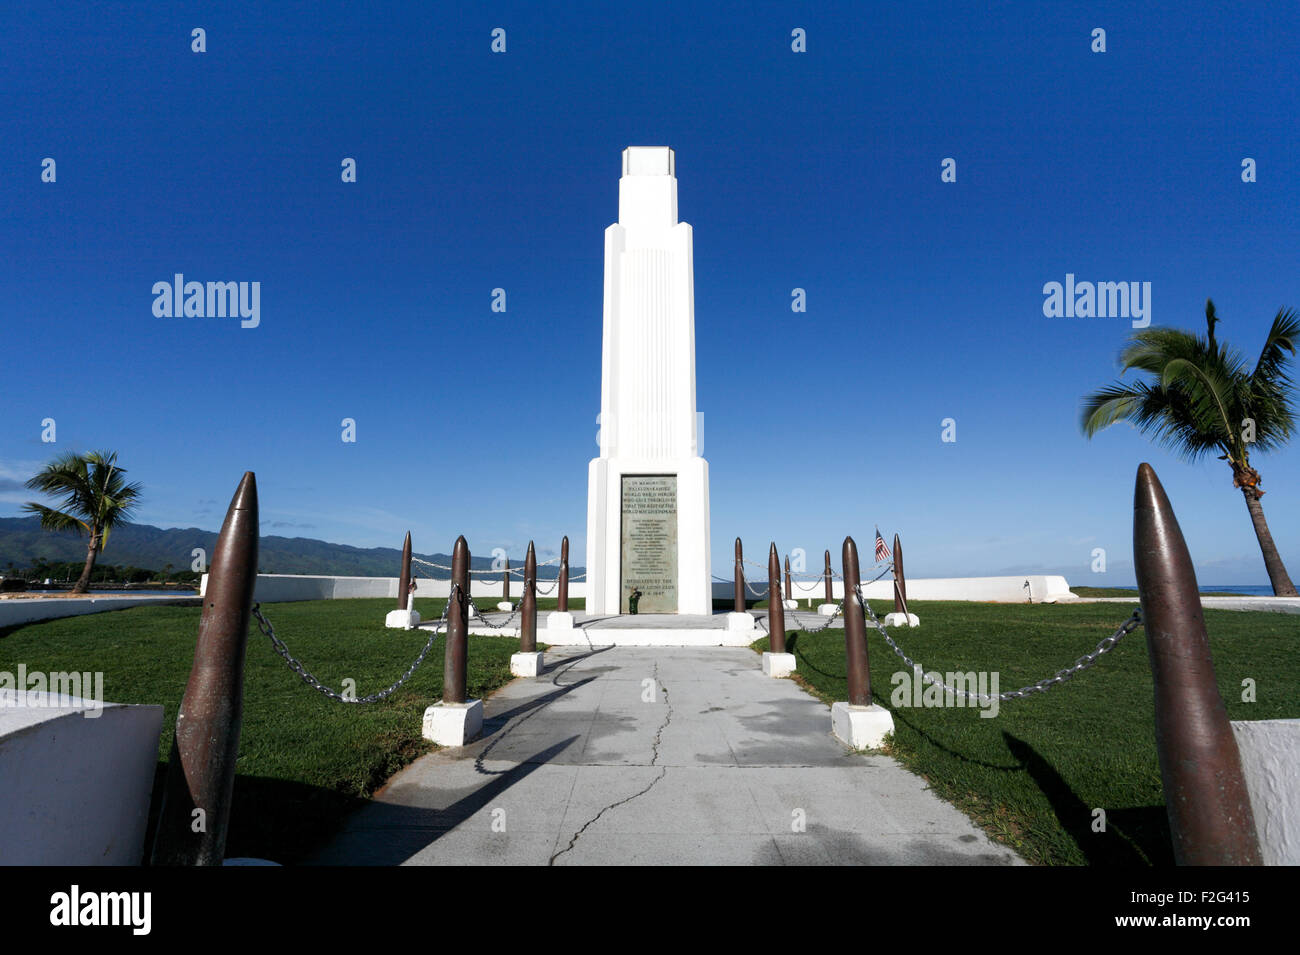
<box><xmin>1134</xmin><ymin>464</ymin><xmax>1261</xmax><ymax>865</ymax></box>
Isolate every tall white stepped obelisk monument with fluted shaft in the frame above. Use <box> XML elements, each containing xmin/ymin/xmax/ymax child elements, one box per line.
<box><xmin>586</xmin><ymin>146</ymin><xmax>712</xmax><ymax>613</ymax></box>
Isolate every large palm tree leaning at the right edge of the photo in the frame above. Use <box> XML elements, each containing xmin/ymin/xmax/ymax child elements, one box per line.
<box><xmin>1080</xmin><ymin>299</ymin><xmax>1300</xmax><ymax>596</ymax></box>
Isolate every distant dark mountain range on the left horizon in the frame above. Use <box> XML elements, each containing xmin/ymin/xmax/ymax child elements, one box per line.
<box><xmin>0</xmin><ymin>517</ymin><xmax>582</xmax><ymax>579</ymax></box>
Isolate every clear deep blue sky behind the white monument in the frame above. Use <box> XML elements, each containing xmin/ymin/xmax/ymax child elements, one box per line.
<box><xmin>0</xmin><ymin>0</ymin><xmax>1300</xmax><ymax>583</ymax></box>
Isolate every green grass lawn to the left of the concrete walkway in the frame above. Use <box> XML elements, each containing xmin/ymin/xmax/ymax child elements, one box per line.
<box><xmin>0</xmin><ymin>599</ymin><xmax>519</xmax><ymax>863</ymax></box>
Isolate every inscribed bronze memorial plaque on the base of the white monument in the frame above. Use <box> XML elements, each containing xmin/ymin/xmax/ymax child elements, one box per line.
<box><xmin>619</xmin><ymin>474</ymin><xmax>677</xmax><ymax>613</ymax></box>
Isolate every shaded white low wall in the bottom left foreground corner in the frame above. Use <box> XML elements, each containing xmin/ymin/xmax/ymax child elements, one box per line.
<box><xmin>0</xmin><ymin>693</ymin><xmax>163</xmax><ymax>865</ymax></box>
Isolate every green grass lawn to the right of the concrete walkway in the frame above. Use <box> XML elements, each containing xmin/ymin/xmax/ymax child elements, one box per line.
<box><xmin>754</xmin><ymin>600</ymin><xmax>1300</xmax><ymax>865</ymax></box>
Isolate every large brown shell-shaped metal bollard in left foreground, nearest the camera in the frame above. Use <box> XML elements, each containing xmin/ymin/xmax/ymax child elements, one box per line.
<box><xmin>151</xmin><ymin>470</ymin><xmax>259</xmax><ymax>865</ymax></box>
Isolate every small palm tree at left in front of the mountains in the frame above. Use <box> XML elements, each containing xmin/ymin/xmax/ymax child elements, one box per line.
<box><xmin>23</xmin><ymin>451</ymin><xmax>140</xmax><ymax>594</ymax></box>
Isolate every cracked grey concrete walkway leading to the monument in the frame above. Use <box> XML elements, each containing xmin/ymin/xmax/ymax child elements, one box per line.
<box><xmin>312</xmin><ymin>647</ymin><xmax>1021</xmax><ymax>865</ymax></box>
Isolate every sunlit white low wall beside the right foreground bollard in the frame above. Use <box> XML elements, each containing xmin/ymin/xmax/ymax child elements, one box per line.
<box><xmin>1232</xmin><ymin>720</ymin><xmax>1300</xmax><ymax>865</ymax></box>
